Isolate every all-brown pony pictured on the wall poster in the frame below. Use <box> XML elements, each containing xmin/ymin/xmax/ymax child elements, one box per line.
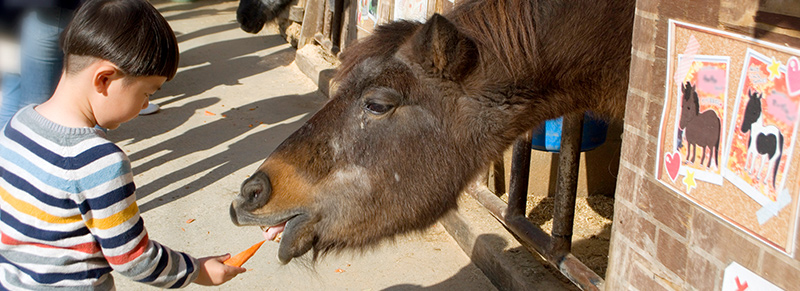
<box><xmin>678</xmin><ymin>82</ymin><xmax>722</xmax><ymax>168</ymax></box>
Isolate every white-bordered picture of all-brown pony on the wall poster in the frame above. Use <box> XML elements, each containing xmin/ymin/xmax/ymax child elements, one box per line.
<box><xmin>672</xmin><ymin>55</ymin><xmax>730</xmax><ymax>185</ymax></box>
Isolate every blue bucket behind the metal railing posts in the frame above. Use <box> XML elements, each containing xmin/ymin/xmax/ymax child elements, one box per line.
<box><xmin>531</xmin><ymin>112</ymin><xmax>608</xmax><ymax>153</ymax></box>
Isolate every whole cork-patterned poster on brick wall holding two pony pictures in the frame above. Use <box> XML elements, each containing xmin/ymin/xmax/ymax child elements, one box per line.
<box><xmin>656</xmin><ymin>20</ymin><xmax>800</xmax><ymax>256</ymax></box>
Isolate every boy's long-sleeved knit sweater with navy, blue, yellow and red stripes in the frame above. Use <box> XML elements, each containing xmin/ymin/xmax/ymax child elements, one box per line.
<box><xmin>0</xmin><ymin>106</ymin><xmax>198</xmax><ymax>290</ymax></box>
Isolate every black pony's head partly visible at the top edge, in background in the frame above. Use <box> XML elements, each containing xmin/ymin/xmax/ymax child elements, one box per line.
<box><xmin>236</xmin><ymin>0</ymin><xmax>292</xmax><ymax>33</ymax></box>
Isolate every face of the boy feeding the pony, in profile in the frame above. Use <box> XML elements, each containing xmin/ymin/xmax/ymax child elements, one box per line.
<box><xmin>95</xmin><ymin>76</ymin><xmax>167</xmax><ymax>129</ymax></box>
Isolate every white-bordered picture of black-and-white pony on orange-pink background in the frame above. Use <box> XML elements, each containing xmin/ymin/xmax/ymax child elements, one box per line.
<box><xmin>723</xmin><ymin>50</ymin><xmax>800</xmax><ymax>206</ymax></box>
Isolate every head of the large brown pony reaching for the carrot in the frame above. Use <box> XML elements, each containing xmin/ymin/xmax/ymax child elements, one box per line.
<box><xmin>231</xmin><ymin>15</ymin><xmax>500</xmax><ymax>263</ymax></box>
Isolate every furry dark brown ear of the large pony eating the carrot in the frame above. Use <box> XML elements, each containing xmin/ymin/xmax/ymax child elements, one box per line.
<box><xmin>410</xmin><ymin>13</ymin><xmax>478</xmax><ymax>80</ymax></box>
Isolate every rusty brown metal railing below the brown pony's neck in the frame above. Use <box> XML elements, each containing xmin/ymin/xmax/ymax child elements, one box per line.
<box><xmin>466</xmin><ymin>114</ymin><xmax>604</xmax><ymax>290</ymax></box>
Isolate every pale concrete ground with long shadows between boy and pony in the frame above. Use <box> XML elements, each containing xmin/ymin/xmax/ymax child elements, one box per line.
<box><xmin>108</xmin><ymin>0</ymin><xmax>496</xmax><ymax>290</ymax></box>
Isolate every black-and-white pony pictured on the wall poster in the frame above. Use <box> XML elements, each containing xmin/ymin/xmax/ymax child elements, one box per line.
<box><xmin>740</xmin><ymin>90</ymin><xmax>783</xmax><ymax>189</ymax></box>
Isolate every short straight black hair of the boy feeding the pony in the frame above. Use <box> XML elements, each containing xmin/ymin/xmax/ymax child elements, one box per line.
<box><xmin>61</xmin><ymin>0</ymin><xmax>179</xmax><ymax>80</ymax></box>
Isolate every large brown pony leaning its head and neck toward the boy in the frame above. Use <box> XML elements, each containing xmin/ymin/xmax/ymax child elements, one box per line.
<box><xmin>230</xmin><ymin>0</ymin><xmax>635</xmax><ymax>263</ymax></box>
